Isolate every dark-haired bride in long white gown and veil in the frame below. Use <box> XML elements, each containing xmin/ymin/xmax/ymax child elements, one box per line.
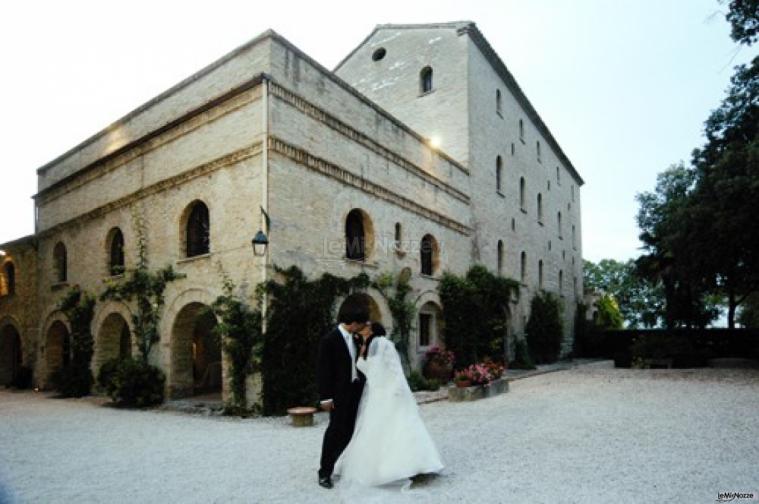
<box><xmin>335</xmin><ymin>322</ymin><xmax>443</xmax><ymax>486</ymax></box>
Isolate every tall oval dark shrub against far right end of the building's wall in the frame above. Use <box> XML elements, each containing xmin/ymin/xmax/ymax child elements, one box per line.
<box><xmin>526</xmin><ymin>291</ymin><xmax>564</xmax><ymax>364</ymax></box>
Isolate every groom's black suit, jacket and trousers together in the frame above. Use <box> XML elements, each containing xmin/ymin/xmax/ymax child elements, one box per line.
<box><xmin>316</xmin><ymin>328</ymin><xmax>366</xmax><ymax>478</ymax></box>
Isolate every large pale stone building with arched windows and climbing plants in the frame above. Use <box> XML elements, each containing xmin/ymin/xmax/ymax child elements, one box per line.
<box><xmin>0</xmin><ymin>22</ymin><xmax>583</xmax><ymax>404</ymax></box>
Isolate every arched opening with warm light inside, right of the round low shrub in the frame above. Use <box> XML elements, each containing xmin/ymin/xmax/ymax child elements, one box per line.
<box><xmin>167</xmin><ymin>301</ymin><xmax>223</xmax><ymax>398</ymax></box>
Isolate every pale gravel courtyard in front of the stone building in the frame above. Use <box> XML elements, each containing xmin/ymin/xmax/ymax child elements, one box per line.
<box><xmin>0</xmin><ymin>366</ymin><xmax>759</xmax><ymax>504</ymax></box>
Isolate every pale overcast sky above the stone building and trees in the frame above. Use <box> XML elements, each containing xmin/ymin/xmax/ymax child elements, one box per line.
<box><xmin>0</xmin><ymin>0</ymin><xmax>756</xmax><ymax>261</ymax></box>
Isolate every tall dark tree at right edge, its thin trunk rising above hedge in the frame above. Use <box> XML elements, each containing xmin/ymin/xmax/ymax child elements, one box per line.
<box><xmin>681</xmin><ymin>57</ymin><xmax>759</xmax><ymax>328</ymax></box>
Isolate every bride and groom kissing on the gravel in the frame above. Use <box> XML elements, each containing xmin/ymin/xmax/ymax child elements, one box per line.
<box><xmin>317</xmin><ymin>306</ymin><xmax>443</xmax><ymax>488</ymax></box>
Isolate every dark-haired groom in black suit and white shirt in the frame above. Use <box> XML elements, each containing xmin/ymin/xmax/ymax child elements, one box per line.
<box><xmin>316</xmin><ymin>306</ymin><xmax>369</xmax><ymax>488</ymax></box>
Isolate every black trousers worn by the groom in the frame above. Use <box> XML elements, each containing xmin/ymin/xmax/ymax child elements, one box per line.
<box><xmin>319</xmin><ymin>381</ymin><xmax>364</xmax><ymax>478</ymax></box>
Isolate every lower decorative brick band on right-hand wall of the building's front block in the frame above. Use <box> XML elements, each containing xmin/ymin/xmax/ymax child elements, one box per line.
<box><xmin>269</xmin><ymin>136</ymin><xmax>471</xmax><ymax>236</ymax></box>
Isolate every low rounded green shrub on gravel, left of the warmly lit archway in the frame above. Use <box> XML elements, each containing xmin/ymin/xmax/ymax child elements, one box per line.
<box><xmin>98</xmin><ymin>358</ymin><xmax>166</xmax><ymax>408</ymax></box>
